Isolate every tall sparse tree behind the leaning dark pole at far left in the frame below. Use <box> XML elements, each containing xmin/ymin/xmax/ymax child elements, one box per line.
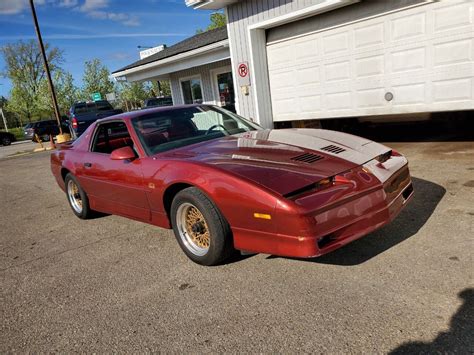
<box><xmin>0</xmin><ymin>40</ymin><xmax>63</xmax><ymax>122</ymax></box>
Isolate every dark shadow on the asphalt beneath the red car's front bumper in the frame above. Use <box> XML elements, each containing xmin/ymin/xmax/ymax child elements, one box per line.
<box><xmin>268</xmin><ymin>177</ymin><xmax>446</xmax><ymax>266</ymax></box>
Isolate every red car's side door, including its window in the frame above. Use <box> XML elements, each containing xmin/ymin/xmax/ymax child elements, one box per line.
<box><xmin>80</xmin><ymin>120</ymin><xmax>150</xmax><ymax>221</ymax></box>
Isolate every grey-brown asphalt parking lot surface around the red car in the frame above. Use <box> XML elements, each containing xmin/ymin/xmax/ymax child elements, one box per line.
<box><xmin>0</xmin><ymin>142</ymin><xmax>474</xmax><ymax>353</ymax></box>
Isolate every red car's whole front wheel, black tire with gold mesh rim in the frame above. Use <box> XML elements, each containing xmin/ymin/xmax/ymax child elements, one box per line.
<box><xmin>171</xmin><ymin>187</ymin><xmax>234</xmax><ymax>266</ymax></box>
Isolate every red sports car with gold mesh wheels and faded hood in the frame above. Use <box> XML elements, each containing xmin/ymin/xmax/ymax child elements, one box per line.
<box><xmin>51</xmin><ymin>105</ymin><xmax>413</xmax><ymax>265</ymax></box>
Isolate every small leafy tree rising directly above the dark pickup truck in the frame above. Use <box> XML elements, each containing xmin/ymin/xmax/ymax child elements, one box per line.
<box><xmin>81</xmin><ymin>58</ymin><xmax>114</xmax><ymax>100</ymax></box>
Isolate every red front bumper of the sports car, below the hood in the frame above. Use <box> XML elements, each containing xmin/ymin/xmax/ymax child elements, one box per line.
<box><xmin>233</xmin><ymin>167</ymin><xmax>413</xmax><ymax>258</ymax></box>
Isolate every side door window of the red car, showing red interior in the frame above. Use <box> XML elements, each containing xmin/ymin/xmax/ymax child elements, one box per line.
<box><xmin>91</xmin><ymin>122</ymin><xmax>133</xmax><ymax>154</ymax></box>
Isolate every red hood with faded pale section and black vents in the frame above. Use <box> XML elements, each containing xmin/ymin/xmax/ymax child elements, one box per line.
<box><xmin>161</xmin><ymin>129</ymin><xmax>390</xmax><ymax>195</ymax></box>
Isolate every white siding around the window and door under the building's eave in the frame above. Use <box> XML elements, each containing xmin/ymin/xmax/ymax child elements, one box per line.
<box><xmin>170</xmin><ymin>59</ymin><xmax>230</xmax><ymax>105</ymax></box>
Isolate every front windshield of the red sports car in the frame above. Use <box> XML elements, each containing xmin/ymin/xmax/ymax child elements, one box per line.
<box><xmin>132</xmin><ymin>106</ymin><xmax>261</xmax><ymax>155</ymax></box>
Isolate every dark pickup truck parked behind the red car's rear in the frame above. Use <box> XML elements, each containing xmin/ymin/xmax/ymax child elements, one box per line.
<box><xmin>69</xmin><ymin>100</ymin><xmax>123</xmax><ymax>138</ymax></box>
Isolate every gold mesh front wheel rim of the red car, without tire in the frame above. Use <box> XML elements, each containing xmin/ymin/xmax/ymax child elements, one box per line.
<box><xmin>176</xmin><ymin>202</ymin><xmax>211</xmax><ymax>256</ymax></box>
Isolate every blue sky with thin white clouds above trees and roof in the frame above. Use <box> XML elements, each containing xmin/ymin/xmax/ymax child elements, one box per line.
<box><xmin>0</xmin><ymin>0</ymin><xmax>210</xmax><ymax>97</ymax></box>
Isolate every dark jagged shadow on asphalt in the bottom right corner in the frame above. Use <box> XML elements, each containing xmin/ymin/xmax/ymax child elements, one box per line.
<box><xmin>389</xmin><ymin>288</ymin><xmax>474</xmax><ymax>355</ymax></box>
